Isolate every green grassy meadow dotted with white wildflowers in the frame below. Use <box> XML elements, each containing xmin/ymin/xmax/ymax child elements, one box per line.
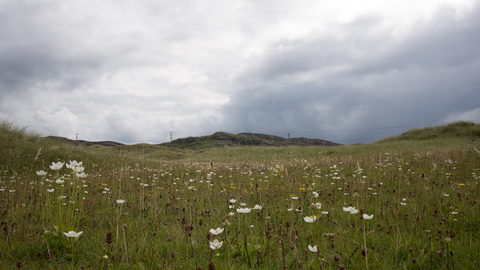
<box><xmin>0</xmin><ymin>121</ymin><xmax>480</xmax><ymax>269</ymax></box>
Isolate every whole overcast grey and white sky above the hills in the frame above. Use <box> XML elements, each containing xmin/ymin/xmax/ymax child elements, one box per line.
<box><xmin>0</xmin><ymin>0</ymin><xmax>480</xmax><ymax>144</ymax></box>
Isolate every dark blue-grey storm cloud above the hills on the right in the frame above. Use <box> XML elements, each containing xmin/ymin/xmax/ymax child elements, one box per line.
<box><xmin>223</xmin><ymin>4</ymin><xmax>480</xmax><ymax>143</ymax></box>
